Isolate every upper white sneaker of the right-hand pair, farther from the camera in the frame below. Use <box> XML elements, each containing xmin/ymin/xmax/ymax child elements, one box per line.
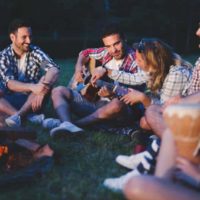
<box><xmin>115</xmin><ymin>151</ymin><xmax>152</xmax><ymax>169</ymax></box>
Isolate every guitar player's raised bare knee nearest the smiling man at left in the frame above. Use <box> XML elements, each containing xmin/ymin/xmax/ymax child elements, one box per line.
<box><xmin>51</xmin><ymin>86</ymin><xmax>71</xmax><ymax>101</ymax></box>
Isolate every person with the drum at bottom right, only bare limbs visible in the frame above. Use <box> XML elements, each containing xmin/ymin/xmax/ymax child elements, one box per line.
<box><xmin>123</xmin><ymin>127</ymin><xmax>200</xmax><ymax>200</ymax></box>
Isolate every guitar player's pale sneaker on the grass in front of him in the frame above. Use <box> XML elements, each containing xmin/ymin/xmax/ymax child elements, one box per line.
<box><xmin>50</xmin><ymin>121</ymin><xmax>83</xmax><ymax>137</ymax></box>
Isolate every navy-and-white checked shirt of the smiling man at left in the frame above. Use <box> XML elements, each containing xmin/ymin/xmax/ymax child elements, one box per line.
<box><xmin>0</xmin><ymin>45</ymin><xmax>59</xmax><ymax>89</ymax></box>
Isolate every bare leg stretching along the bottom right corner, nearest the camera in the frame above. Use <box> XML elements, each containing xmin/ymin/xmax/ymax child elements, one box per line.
<box><xmin>124</xmin><ymin>176</ymin><xmax>199</xmax><ymax>200</ymax></box>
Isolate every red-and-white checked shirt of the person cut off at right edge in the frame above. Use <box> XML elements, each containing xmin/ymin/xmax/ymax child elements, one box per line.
<box><xmin>188</xmin><ymin>57</ymin><xmax>200</xmax><ymax>94</ymax></box>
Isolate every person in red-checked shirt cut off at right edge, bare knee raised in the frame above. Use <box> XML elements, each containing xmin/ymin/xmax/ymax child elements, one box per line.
<box><xmin>113</xmin><ymin>23</ymin><xmax>200</xmax><ymax>169</ymax></box>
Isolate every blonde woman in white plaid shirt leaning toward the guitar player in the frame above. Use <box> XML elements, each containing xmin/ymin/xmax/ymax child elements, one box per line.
<box><xmin>104</xmin><ymin>38</ymin><xmax>192</xmax><ymax>190</ymax></box>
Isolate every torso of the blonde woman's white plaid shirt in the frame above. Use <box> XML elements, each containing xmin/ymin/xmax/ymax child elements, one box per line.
<box><xmin>152</xmin><ymin>65</ymin><xmax>192</xmax><ymax>104</ymax></box>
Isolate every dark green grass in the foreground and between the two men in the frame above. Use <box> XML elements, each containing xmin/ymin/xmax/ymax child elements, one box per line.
<box><xmin>0</xmin><ymin>59</ymin><xmax>134</xmax><ymax>200</ymax></box>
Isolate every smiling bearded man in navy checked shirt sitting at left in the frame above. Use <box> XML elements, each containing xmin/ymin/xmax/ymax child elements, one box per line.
<box><xmin>0</xmin><ymin>19</ymin><xmax>59</xmax><ymax>127</ymax></box>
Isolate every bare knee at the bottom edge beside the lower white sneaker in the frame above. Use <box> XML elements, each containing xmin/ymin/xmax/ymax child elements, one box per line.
<box><xmin>123</xmin><ymin>177</ymin><xmax>146</xmax><ymax>200</ymax></box>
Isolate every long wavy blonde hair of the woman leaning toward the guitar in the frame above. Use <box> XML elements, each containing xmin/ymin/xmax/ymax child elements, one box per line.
<box><xmin>136</xmin><ymin>38</ymin><xmax>191</xmax><ymax>92</ymax></box>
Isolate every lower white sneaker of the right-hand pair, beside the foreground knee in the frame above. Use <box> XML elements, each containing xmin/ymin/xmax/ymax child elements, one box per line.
<box><xmin>103</xmin><ymin>170</ymin><xmax>141</xmax><ymax>191</ymax></box>
